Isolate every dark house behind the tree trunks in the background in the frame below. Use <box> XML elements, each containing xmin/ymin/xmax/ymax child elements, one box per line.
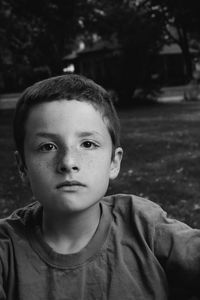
<box><xmin>63</xmin><ymin>41</ymin><xmax>196</xmax><ymax>89</ymax></box>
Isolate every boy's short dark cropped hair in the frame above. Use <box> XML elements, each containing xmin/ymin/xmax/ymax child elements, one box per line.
<box><xmin>13</xmin><ymin>74</ymin><xmax>120</xmax><ymax>162</ymax></box>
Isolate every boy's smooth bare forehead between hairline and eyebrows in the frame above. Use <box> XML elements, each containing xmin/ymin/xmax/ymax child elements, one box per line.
<box><xmin>25</xmin><ymin>99</ymin><xmax>111</xmax><ymax>138</ymax></box>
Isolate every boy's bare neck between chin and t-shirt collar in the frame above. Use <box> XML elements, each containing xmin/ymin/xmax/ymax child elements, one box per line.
<box><xmin>42</xmin><ymin>203</ymin><xmax>101</xmax><ymax>254</ymax></box>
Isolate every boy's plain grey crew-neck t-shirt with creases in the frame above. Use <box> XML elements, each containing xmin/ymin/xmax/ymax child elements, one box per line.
<box><xmin>0</xmin><ymin>195</ymin><xmax>200</xmax><ymax>300</ymax></box>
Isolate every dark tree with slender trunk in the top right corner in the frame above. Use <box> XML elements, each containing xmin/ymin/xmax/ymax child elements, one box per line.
<box><xmin>148</xmin><ymin>0</ymin><xmax>200</xmax><ymax>80</ymax></box>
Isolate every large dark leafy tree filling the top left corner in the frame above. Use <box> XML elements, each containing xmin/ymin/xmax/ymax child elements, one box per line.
<box><xmin>0</xmin><ymin>0</ymin><xmax>95</xmax><ymax>91</ymax></box>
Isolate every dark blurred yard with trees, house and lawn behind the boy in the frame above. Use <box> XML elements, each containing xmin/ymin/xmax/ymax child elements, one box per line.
<box><xmin>0</xmin><ymin>0</ymin><xmax>200</xmax><ymax>227</ymax></box>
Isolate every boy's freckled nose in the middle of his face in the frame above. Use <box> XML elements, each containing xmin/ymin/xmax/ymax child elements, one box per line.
<box><xmin>57</xmin><ymin>150</ymin><xmax>79</xmax><ymax>173</ymax></box>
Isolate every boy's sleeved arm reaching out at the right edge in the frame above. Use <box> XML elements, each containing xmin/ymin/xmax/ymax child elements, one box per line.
<box><xmin>154</xmin><ymin>211</ymin><xmax>200</xmax><ymax>295</ymax></box>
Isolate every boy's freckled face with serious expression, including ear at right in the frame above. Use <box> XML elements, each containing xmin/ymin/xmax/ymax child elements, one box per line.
<box><xmin>18</xmin><ymin>100</ymin><xmax>122</xmax><ymax>213</ymax></box>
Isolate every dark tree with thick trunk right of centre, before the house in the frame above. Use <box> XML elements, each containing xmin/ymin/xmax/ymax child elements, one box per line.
<box><xmin>82</xmin><ymin>0</ymin><xmax>164</xmax><ymax>100</ymax></box>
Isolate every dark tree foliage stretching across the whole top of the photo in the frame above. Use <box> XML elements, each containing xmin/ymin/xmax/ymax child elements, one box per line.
<box><xmin>0</xmin><ymin>0</ymin><xmax>200</xmax><ymax>92</ymax></box>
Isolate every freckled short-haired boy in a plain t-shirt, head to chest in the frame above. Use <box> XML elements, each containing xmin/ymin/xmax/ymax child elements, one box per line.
<box><xmin>0</xmin><ymin>75</ymin><xmax>200</xmax><ymax>300</ymax></box>
